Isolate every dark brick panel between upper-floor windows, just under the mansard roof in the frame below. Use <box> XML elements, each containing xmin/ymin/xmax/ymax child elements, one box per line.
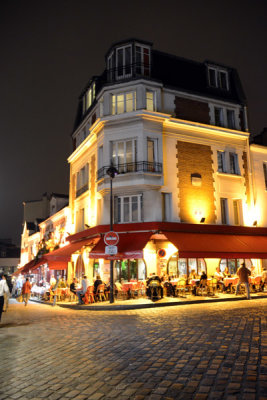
<box><xmin>174</xmin><ymin>96</ymin><xmax>210</xmax><ymax>124</ymax></box>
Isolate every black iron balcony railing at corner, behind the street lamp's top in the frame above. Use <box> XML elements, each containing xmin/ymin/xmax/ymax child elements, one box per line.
<box><xmin>97</xmin><ymin>161</ymin><xmax>162</xmax><ymax>180</ymax></box>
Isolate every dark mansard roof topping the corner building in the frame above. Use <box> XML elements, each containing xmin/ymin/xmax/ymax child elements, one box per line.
<box><xmin>74</xmin><ymin>38</ymin><xmax>246</xmax><ymax>130</ymax></box>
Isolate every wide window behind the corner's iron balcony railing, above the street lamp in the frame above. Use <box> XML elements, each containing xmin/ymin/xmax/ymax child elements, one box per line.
<box><xmin>111</xmin><ymin>139</ymin><xmax>137</xmax><ymax>173</ymax></box>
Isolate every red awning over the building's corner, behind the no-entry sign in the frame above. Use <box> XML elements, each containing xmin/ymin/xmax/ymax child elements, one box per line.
<box><xmin>89</xmin><ymin>232</ymin><xmax>152</xmax><ymax>260</ymax></box>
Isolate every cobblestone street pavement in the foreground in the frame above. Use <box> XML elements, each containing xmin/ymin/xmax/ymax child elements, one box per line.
<box><xmin>0</xmin><ymin>299</ymin><xmax>267</xmax><ymax>400</ymax></box>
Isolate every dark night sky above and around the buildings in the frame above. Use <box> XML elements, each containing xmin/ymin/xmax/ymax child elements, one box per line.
<box><xmin>0</xmin><ymin>0</ymin><xmax>267</xmax><ymax>244</ymax></box>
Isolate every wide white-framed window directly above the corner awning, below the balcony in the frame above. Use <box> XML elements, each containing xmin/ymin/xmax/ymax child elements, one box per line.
<box><xmin>114</xmin><ymin>194</ymin><xmax>142</xmax><ymax>223</ymax></box>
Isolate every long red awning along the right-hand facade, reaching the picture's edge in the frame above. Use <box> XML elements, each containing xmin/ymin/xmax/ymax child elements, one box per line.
<box><xmin>163</xmin><ymin>232</ymin><xmax>267</xmax><ymax>259</ymax></box>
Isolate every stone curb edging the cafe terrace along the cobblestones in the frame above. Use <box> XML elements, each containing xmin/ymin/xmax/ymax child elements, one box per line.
<box><xmin>30</xmin><ymin>295</ymin><xmax>267</xmax><ymax>311</ymax></box>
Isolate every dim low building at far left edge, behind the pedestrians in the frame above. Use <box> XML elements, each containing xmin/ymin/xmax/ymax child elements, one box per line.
<box><xmin>0</xmin><ymin>239</ymin><xmax>20</xmax><ymax>275</ymax></box>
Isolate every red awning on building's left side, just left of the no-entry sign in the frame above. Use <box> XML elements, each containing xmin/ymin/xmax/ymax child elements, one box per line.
<box><xmin>44</xmin><ymin>237</ymin><xmax>100</xmax><ymax>262</ymax></box>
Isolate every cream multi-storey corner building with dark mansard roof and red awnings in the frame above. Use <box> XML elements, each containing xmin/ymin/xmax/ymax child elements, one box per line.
<box><xmin>65</xmin><ymin>39</ymin><xmax>267</xmax><ymax>280</ymax></box>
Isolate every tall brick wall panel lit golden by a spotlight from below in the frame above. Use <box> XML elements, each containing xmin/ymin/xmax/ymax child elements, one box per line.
<box><xmin>176</xmin><ymin>141</ymin><xmax>216</xmax><ymax>224</ymax></box>
